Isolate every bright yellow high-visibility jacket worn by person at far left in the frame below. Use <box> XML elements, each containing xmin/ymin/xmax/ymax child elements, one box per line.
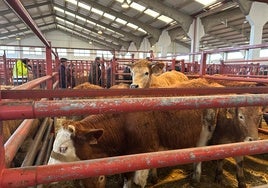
<box><xmin>13</xmin><ymin>60</ymin><xmax>28</xmax><ymax>83</ymax></box>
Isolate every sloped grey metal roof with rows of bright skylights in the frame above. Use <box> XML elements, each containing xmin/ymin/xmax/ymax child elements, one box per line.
<box><xmin>0</xmin><ymin>0</ymin><xmax>268</xmax><ymax>49</ymax></box>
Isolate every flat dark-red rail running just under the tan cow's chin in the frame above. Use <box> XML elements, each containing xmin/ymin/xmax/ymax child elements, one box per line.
<box><xmin>1</xmin><ymin>86</ymin><xmax>268</xmax><ymax>99</ymax></box>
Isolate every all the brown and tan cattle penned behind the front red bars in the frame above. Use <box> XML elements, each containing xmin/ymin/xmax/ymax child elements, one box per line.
<box><xmin>45</xmin><ymin>60</ymin><xmax>264</xmax><ymax>188</ymax></box>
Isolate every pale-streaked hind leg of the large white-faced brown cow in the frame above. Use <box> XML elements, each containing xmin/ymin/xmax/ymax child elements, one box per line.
<box><xmin>193</xmin><ymin>109</ymin><xmax>218</xmax><ymax>182</ymax></box>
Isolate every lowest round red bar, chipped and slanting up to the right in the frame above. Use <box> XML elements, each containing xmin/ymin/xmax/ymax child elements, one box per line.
<box><xmin>0</xmin><ymin>140</ymin><xmax>268</xmax><ymax>187</ymax></box>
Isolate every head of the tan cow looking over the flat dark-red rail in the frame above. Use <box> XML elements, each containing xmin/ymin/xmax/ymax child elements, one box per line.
<box><xmin>130</xmin><ymin>59</ymin><xmax>164</xmax><ymax>88</ymax></box>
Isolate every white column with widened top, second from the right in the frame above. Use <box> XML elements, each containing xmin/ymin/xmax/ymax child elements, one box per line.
<box><xmin>187</xmin><ymin>18</ymin><xmax>205</xmax><ymax>61</ymax></box>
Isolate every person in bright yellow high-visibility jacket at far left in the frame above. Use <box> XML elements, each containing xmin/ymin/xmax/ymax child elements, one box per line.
<box><xmin>13</xmin><ymin>59</ymin><xmax>29</xmax><ymax>85</ymax></box>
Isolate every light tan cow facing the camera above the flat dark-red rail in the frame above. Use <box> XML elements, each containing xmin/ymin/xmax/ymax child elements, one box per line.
<box><xmin>129</xmin><ymin>59</ymin><xmax>188</xmax><ymax>88</ymax></box>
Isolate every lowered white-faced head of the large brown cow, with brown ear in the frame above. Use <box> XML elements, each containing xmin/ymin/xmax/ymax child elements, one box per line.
<box><xmin>48</xmin><ymin>125</ymin><xmax>106</xmax><ymax>188</ymax></box>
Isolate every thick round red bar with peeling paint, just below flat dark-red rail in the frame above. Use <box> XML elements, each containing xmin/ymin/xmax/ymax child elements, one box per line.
<box><xmin>0</xmin><ymin>94</ymin><xmax>268</xmax><ymax>120</ymax></box>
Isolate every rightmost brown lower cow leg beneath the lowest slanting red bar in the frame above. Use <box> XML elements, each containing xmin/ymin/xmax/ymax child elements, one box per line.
<box><xmin>234</xmin><ymin>156</ymin><xmax>247</xmax><ymax>188</ymax></box>
